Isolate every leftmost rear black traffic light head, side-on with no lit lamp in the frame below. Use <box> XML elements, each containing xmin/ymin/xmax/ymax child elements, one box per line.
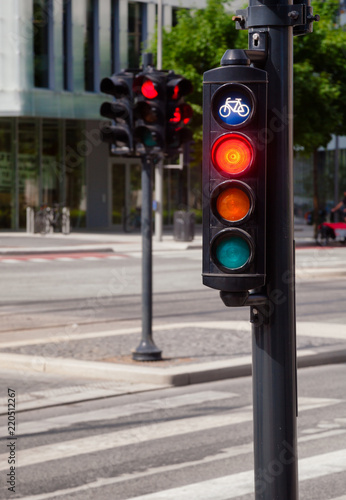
<box><xmin>100</xmin><ymin>71</ymin><xmax>133</xmax><ymax>153</ymax></box>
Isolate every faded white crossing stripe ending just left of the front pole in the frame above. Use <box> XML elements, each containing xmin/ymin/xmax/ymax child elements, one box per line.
<box><xmin>19</xmin><ymin>391</ymin><xmax>237</xmax><ymax>435</ymax></box>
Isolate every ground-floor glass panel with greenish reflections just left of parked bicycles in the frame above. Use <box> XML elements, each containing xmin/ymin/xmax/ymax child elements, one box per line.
<box><xmin>18</xmin><ymin>120</ymin><xmax>39</xmax><ymax>228</ymax></box>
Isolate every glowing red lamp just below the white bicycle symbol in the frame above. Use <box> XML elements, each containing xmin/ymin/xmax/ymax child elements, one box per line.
<box><xmin>211</xmin><ymin>133</ymin><xmax>254</xmax><ymax>175</ymax></box>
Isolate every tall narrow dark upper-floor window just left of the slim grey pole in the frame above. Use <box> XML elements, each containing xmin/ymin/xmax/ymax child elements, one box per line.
<box><xmin>128</xmin><ymin>2</ymin><xmax>143</xmax><ymax>68</ymax></box>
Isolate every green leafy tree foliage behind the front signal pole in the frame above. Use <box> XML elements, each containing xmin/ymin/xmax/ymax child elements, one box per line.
<box><xmin>153</xmin><ymin>0</ymin><xmax>346</xmax><ymax>154</ymax></box>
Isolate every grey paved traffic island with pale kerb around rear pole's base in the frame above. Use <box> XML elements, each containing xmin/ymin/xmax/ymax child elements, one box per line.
<box><xmin>0</xmin><ymin>320</ymin><xmax>346</xmax><ymax>386</ymax></box>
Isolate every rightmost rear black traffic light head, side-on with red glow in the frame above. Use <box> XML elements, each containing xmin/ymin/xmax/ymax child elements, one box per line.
<box><xmin>166</xmin><ymin>71</ymin><xmax>193</xmax><ymax>154</ymax></box>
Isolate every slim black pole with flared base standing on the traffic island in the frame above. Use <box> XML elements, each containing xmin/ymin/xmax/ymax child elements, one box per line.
<box><xmin>132</xmin><ymin>155</ymin><xmax>162</xmax><ymax>361</ymax></box>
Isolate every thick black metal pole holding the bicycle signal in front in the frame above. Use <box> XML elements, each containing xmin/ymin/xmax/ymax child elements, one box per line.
<box><xmin>249</xmin><ymin>0</ymin><xmax>298</xmax><ymax>500</ymax></box>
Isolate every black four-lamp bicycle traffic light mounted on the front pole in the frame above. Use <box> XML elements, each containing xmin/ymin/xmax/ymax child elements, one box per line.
<box><xmin>203</xmin><ymin>51</ymin><xmax>267</xmax><ymax>292</ymax></box>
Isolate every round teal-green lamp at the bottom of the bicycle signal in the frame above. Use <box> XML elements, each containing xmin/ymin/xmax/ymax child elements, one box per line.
<box><xmin>214</xmin><ymin>235</ymin><xmax>251</xmax><ymax>270</ymax></box>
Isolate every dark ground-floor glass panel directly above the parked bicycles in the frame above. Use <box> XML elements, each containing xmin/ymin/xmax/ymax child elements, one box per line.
<box><xmin>41</xmin><ymin>120</ymin><xmax>63</xmax><ymax>207</ymax></box>
